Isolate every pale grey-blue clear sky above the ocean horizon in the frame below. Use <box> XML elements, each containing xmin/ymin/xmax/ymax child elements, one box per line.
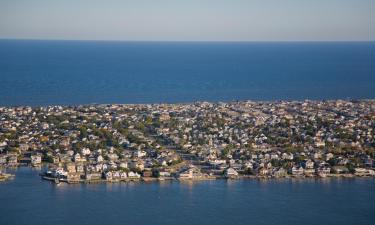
<box><xmin>0</xmin><ymin>0</ymin><xmax>375</xmax><ymax>41</ymax></box>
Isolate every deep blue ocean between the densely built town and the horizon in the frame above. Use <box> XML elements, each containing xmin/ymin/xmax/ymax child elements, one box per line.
<box><xmin>0</xmin><ymin>40</ymin><xmax>375</xmax><ymax>105</ymax></box>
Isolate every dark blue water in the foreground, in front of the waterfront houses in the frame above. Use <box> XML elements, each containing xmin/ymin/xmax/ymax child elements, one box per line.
<box><xmin>0</xmin><ymin>168</ymin><xmax>375</xmax><ymax>225</ymax></box>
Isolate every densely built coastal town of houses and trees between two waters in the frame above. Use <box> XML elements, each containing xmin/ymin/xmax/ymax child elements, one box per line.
<box><xmin>0</xmin><ymin>100</ymin><xmax>375</xmax><ymax>183</ymax></box>
